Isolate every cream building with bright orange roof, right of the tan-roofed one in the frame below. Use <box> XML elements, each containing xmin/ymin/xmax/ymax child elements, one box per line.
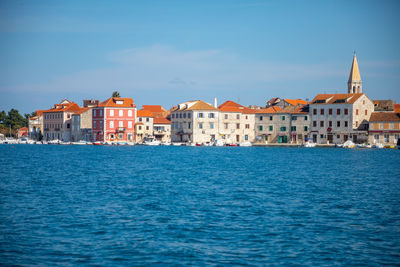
<box><xmin>218</xmin><ymin>101</ymin><xmax>255</xmax><ymax>144</ymax></box>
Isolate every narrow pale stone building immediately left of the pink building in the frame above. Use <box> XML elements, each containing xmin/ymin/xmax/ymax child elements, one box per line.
<box><xmin>71</xmin><ymin>107</ymin><xmax>92</xmax><ymax>142</ymax></box>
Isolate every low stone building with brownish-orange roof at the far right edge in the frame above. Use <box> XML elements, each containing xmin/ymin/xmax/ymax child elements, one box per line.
<box><xmin>368</xmin><ymin>112</ymin><xmax>400</xmax><ymax>145</ymax></box>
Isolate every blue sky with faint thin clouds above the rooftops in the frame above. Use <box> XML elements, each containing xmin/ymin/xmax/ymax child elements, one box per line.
<box><xmin>0</xmin><ymin>0</ymin><xmax>400</xmax><ymax>113</ymax></box>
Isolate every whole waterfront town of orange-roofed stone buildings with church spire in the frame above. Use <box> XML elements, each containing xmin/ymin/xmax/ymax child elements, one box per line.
<box><xmin>3</xmin><ymin>54</ymin><xmax>400</xmax><ymax>146</ymax></box>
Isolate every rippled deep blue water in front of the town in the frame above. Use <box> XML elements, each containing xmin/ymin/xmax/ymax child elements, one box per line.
<box><xmin>0</xmin><ymin>145</ymin><xmax>400</xmax><ymax>266</ymax></box>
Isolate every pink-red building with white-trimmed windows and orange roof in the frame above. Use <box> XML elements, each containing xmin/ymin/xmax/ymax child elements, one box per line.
<box><xmin>92</xmin><ymin>97</ymin><xmax>136</xmax><ymax>142</ymax></box>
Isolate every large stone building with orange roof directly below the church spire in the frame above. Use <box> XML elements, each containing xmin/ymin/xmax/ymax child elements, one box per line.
<box><xmin>310</xmin><ymin>94</ymin><xmax>374</xmax><ymax>144</ymax></box>
